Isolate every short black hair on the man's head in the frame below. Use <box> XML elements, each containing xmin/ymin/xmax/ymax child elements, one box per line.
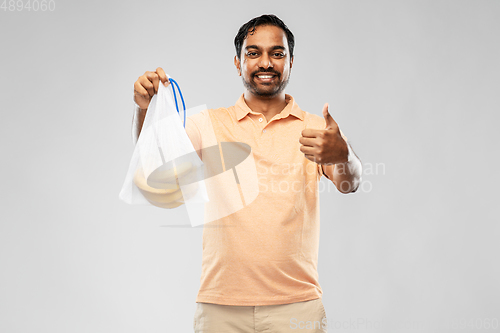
<box><xmin>234</xmin><ymin>14</ymin><xmax>295</xmax><ymax>59</ymax></box>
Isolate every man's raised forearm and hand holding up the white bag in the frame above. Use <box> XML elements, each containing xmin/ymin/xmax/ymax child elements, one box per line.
<box><xmin>132</xmin><ymin>67</ymin><xmax>170</xmax><ymax>144</ymax></box>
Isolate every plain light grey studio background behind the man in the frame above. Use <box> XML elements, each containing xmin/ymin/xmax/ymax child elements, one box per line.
<box><xmin>0</xmin><ymin>0</ymin><xmax>500</xmax><ymax>333</ymax></box>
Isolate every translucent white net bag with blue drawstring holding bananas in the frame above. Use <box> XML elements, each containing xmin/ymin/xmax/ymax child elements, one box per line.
<box><xmin>119</xmin><ymin>78</ymin><xmax>208</xmax><ymax>212</ymax></box>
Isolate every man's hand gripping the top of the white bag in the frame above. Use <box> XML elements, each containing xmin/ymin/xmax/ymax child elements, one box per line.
<box><xmin>134</xmin><ymin>67</ymin><xmax>170</xmax><ymax>110</ymax></box>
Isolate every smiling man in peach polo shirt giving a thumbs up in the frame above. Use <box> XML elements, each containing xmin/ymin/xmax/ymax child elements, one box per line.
<box><xmin>134</xmin><ymin>15</ymin><xmax>361</xmax><ymax>333</ymax></box>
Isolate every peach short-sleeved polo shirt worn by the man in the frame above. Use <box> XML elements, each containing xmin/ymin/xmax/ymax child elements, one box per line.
<box><xmin>186</xmin><ymin>95</ymin><xmax>325</xmax><ymax>306</ymax></box>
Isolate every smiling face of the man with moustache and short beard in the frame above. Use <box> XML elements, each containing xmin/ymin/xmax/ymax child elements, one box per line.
<box><xmin>234</xmin><ymin>25</ymin><xmax>293</xmax><ymax>97</ymax></box>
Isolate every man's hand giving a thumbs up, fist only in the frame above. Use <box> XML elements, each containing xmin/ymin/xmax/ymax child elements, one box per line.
<box><xmin>299</xmin><ymin>103</ymin><xmax>349</xmax><ymax>164</ymax></box>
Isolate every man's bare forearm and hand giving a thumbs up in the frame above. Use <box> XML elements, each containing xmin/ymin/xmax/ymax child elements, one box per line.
<box><xmin>299</xmin><ymin>104</ymin><xmax>362</xmax><ymax>194</ymax></box>
